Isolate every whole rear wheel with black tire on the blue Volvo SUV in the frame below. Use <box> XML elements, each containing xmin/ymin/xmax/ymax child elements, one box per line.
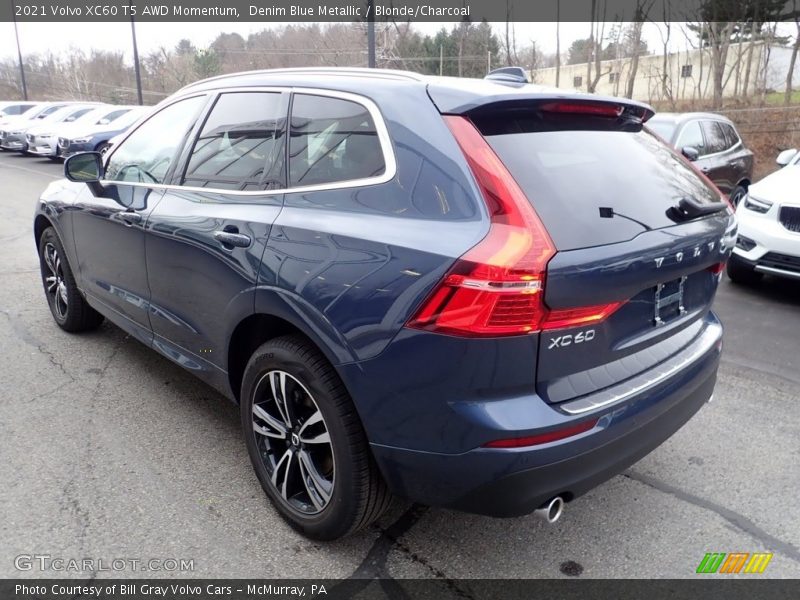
<box><xmin>240</xmin><ymin>335</ymin><xmax>392</xmax><ymax>540</ymax></box>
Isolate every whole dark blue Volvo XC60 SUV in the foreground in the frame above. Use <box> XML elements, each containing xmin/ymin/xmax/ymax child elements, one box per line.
<box><xmin>34</xmin><ymin>69</ymin><xmax>736</xmax><ymax>539</ymax></box>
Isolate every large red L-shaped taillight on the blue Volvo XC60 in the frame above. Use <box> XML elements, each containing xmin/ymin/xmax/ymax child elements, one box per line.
<box><xmin>408</xmin><ymin>116</ymin><xmax>621</xmax><ymax>337</ymax></box>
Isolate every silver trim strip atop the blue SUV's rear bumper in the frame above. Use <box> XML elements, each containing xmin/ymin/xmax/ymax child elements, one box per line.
<box><xmin>557</xmin><ymin>323</ymin><xmax>722</xmax><ymax>415</ymax></box>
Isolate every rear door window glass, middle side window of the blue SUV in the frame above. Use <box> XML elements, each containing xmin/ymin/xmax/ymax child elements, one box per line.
<box><xmin>182</xmin><ymin>92</ymin><xmax>288</xmax><ymax>190</ymax></box>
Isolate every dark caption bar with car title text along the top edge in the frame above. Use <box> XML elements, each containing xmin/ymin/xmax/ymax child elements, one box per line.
<box><xmin>0</xmin><ymin>0</ymin><xmax>798</xmax><ymax>23</ymax></box>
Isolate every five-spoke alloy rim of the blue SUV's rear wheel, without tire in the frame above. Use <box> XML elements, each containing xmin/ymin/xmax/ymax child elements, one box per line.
<box><xmin>252</xmin><ymin>370</ymin><xmax>335</xmax><ymax>516</ymax></box>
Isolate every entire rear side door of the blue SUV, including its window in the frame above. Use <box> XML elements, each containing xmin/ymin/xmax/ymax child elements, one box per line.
<box><xmin>146</xmin><ymin>91</ymin><xmax>289</xmax><ymax>380</ymax></box>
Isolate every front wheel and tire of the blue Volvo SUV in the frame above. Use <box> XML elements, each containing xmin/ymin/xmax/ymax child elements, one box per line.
<box><xmin>39</xmin><ymin>227</ymin><xmax>103</xmax><ymax>333</ymax></box>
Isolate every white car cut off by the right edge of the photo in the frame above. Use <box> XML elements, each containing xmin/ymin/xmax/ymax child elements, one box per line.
<box><xmin>728</xmin><ymin>149</ymin><xmax>800</xmax><ymax>283</ymax></box>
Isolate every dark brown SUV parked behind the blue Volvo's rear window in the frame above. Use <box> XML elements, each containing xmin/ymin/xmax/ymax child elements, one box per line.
<box><xmin>647</xmin><ymin>113</ymin><xmax>753</xmax><ymax>206</ymax></box>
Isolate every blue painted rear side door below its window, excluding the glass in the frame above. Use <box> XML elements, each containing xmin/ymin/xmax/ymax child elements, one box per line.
<box><xmin>146</xmin><ymin>188</ymin><xmax>283</xmax><ymax>370</ymax></box>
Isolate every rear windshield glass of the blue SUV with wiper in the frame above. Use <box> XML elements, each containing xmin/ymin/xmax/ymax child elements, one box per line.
<box><xmin>477</xmin><ymin>119</ymin><xmax>720</xmax><ymax>250</ymax></box>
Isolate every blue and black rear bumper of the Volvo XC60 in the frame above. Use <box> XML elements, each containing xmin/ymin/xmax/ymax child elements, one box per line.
<box><xmin>373</xmin><ymin>315</ymin><xmax>721</xmax><ymax>517</ymax></box>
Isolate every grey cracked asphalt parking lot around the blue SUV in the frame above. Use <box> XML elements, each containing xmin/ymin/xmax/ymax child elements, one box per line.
<box><xmin>0</xmin><ymin>153</ymin><xmax>800</xmax><ymax>580</ymax></box>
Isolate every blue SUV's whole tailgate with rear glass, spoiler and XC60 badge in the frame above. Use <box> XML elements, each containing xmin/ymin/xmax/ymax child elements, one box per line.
<box><xmin>438</xmin><ymin>86</ymin><xmax>735</xmax><ymax>403</ymax></box>
